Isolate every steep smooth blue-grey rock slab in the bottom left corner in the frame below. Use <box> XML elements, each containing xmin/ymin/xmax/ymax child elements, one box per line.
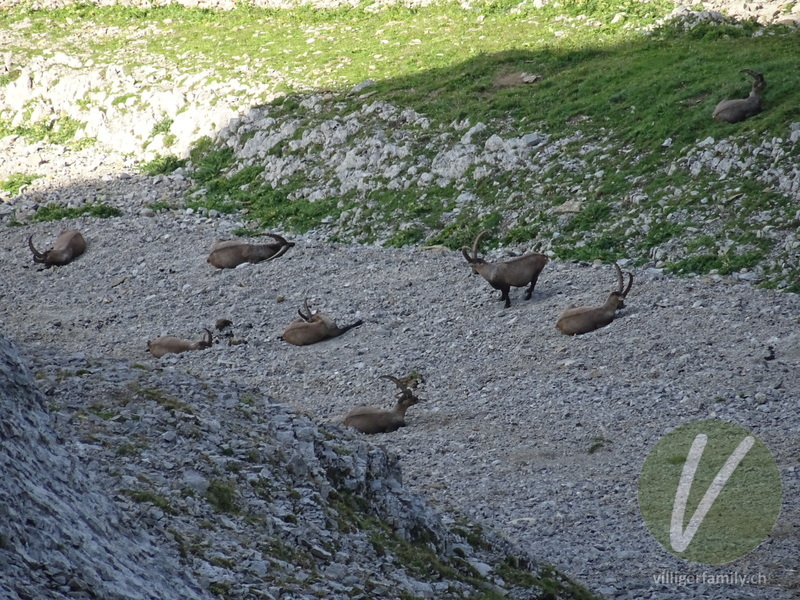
<box><xmin>0</xmin><ymin>336</ymin><xmax>213</xmax><ymax>600</ymax></box>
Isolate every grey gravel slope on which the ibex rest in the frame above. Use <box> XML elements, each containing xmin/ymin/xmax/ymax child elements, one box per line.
<box><xmin>0</xmin><ymin>203</ymin><xmax>800</xmax><ymax>600</ymax></box>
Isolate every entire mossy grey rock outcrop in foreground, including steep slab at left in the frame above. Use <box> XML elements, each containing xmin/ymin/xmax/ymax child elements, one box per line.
<box><xmin>0</xmin><ymin>338</ymin><xmax>583</xmax><ymax>600</ymax></box>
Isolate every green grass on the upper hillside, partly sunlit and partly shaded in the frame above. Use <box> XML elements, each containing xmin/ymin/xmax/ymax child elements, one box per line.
<box><xmin>0</xmin><ymin>0</ymin><xmax>800</xmax><ymax>283</ymax></box>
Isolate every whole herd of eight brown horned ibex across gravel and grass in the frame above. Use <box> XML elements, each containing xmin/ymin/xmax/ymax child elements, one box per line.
<box><xmin>28</xmin><ymin>69</ymin><xmax>767</xmax><ymax>434</ymax></box>
